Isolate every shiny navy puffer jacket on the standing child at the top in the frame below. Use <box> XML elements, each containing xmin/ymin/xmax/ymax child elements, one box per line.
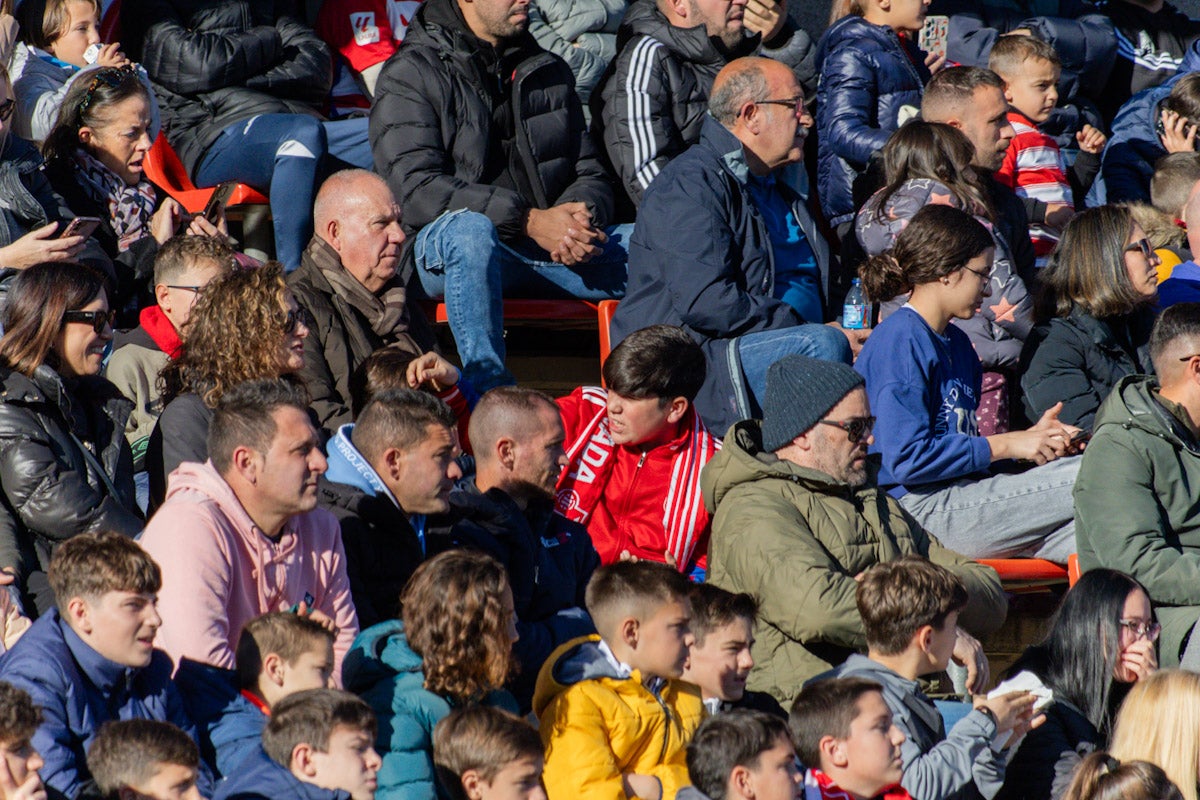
<box><xmin>817</xmin><ymin>16</ymin><xmax>929</xmax><ymax>225</ymax></box>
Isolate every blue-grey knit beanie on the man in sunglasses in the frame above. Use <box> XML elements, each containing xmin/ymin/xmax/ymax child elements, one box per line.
<box><xmin>762</xmin><ymin>355</ymin><xmax>863</xmax><ymax>452</ymax></box>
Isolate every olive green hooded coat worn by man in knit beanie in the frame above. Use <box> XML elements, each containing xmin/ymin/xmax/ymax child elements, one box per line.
<box><xmin>701</xmin><ymin>420</ymin><xmax>1007</xmax><ymax>700</ymax></box>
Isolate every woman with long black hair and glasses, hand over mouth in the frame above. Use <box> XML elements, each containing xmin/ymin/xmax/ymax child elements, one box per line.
<box><xmin>996</xmin><ymin>569</ymin><xmax>1160</xmax><ymax>800</ymax></box>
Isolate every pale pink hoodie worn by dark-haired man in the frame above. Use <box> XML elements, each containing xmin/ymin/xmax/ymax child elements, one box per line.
<box><xmin>140</xmin><ymin>462</ymin><xmax>359</xmax><ymax>686</ymax></box>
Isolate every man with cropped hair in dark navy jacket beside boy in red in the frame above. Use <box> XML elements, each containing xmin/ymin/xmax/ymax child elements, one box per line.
<box><xmin>427</xmin><ymin>386</ymin><xmax>600</xmax><ymax>710</ymax></box>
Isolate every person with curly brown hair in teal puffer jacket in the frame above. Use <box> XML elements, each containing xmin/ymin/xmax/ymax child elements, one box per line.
<box><xmin>342</xmin><ymin>549</ymin><xmax>517</xmax><ymax>800</ymax></box>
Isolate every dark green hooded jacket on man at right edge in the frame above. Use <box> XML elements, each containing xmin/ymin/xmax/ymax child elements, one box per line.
<box><xmin>1075</xmin><ymin>375</ymin><xmax>1200</xmax><ymax>668</ymax></box>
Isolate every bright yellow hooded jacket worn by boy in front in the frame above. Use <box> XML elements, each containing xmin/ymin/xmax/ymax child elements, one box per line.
<box><xmin>533</xmin><ymin>636</ymin><xmax>704</xmax><ymax>800</ymax></box>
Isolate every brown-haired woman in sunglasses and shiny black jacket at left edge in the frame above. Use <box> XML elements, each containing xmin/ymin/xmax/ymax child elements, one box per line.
<box><xmin>0</xmin><ymin>263</ymin><xmax>142</xmax><ymax>616</ymax></box>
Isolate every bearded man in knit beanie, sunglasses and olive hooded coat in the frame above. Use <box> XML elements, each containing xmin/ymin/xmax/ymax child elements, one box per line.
<box><xmin>701</xmin><ymin>355</ymin><xmax>1007</xmax><ymax>705</ymax></box>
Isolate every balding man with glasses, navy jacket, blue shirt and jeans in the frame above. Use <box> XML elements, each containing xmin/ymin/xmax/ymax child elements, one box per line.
<box><xmin>612</xmin><ymin>58</ymin><xmax>865</xmax><ymax>432</ymax></box>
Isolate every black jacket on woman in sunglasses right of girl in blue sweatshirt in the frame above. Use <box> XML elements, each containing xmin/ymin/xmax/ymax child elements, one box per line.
<box><xmin>1021</xmin><ymin>308</ymin><xmax>1154</xmax><ymax>431</ymax></box>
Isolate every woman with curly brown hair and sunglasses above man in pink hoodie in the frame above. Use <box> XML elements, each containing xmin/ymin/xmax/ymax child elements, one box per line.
<box><xmin>145</xmin><ymin>261</ymin><xmax>308</xmax><ymax>510</ymax></box>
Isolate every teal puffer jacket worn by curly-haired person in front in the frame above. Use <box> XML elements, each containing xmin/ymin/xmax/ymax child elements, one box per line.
<box><xmin>343</xmin><ymin>620</ymin><xmax>517</xmax><ymax>800</ymax></box>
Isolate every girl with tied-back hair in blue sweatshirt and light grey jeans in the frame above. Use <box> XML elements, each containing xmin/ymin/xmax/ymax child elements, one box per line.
<box><xmin>854</xmin><ymin>205</ymin><xmax>1079</xmax><ymax>564</ymax></box>
